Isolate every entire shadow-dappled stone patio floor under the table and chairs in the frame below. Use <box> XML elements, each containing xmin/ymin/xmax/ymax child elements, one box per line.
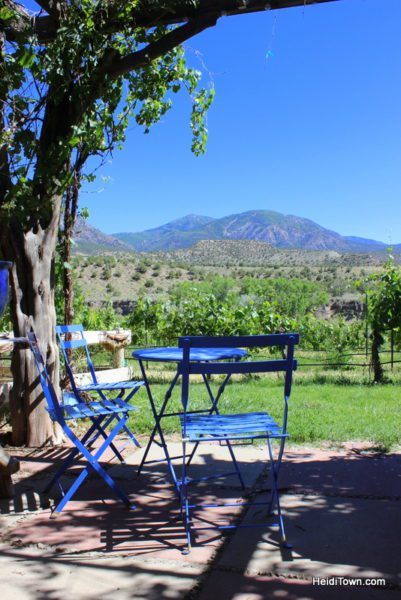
<box><xmin>0</xmin><ymin>442</ymin><xmax>401</xmax><ymax>600</ymax></box>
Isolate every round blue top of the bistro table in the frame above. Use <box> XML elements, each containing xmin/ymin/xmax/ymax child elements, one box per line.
<box><xmin>132</xmin><ymin>347</ymin><xmax>248</xmax><ymax>362</ymax></box>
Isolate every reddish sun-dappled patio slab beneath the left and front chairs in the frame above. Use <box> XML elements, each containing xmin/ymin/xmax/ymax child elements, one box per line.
<box><xmin>2</xmin><ymin>481</ymin><xmax>245</xmax><ymax>564</ymax></box>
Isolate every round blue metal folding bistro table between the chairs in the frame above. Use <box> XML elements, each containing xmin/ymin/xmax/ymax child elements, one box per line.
<box><xmin>132</xmin><ymin>347</ymin><xmax>248</xmax><ymax>493</ymax></box>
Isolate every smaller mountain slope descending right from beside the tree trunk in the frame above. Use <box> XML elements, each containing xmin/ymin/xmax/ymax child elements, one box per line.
<box><xmin>73</xmin><ymin>217</ymin><xmax>134</xmax><ymax>254</ymax></box>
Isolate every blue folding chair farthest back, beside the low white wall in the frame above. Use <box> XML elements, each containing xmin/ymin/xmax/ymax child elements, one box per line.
<box><xmin>56</xmin><ymin>325</ymin><xmax>144</xmax><ymax>463</ymax></box>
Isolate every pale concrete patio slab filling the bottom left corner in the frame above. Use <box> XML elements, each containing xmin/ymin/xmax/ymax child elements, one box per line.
<box><xmin>0</xmin><ymin>546</ymin><xmax>202</xmax><ymax>600</ymax></box>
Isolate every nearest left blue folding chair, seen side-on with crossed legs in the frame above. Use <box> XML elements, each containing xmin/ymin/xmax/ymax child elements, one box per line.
<box><xmin>27</xmin><ymin>331</ymin><xmax>138</xmax><ymax>516</ymax></box>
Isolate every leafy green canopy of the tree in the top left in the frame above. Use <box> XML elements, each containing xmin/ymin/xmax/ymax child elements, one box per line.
<box><xmin>0</xmin><ymin>0</ymin><xmax>213</xmax><ymax>226</ymax></box>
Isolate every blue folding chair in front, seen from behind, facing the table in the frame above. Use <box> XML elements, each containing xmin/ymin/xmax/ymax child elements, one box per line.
<box><xmin>178</xmin><ymin>333</ymin><xmax>299</xmax><ymax>554</ymax></box>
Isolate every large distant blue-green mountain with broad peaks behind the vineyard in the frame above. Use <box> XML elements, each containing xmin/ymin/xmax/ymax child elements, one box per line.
<box><xmin>114</xmin><ymin>210</ymin><xmax>386</xmax><ymax>252</ymax></box>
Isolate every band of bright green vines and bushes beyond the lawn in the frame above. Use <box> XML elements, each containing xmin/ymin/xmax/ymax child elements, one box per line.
<box><xmin>126</xmin><ymin>277</ymin><xmax>364</xmax><ymax>352</ymax></box>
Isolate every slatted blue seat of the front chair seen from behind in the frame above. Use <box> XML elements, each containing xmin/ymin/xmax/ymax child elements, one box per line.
<box><xmin>180</xmin><ymin>412</ymin><xmax>287</xmax><ymax>442</ymax></box>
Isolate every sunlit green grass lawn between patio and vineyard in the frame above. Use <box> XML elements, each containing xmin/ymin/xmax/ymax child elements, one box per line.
<box><xmin>131</xmin><ymin>377</ymin><xmax>401</xmax><ymax>449</ymax></box>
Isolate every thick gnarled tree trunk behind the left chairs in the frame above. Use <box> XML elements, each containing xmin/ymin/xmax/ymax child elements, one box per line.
<box><xmin>2</xmin><ymin>206</ymin><xmax>61</xmax><ymax>447</ymax></box>
